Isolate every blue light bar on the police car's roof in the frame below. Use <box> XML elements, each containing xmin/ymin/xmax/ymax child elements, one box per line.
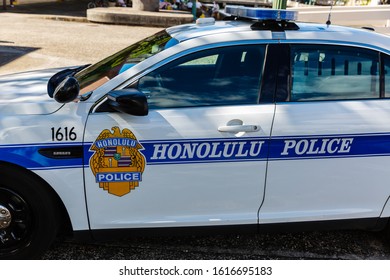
<box><xmin>225</xmin><ymin>6</ymin><xmax>298</xmax><ymax>21</ymax></box>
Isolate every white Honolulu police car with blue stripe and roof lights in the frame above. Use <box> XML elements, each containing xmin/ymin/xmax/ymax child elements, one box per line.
<box><xmin>0</xmin><ymin>7</ymin><xmax>390</xmax><ymax>259</ymax></box>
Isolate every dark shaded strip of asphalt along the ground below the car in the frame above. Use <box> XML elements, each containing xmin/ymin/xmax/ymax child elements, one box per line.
<box><xmin>44</xmin><ymin>231</ymin><xmax>390</xmax><ymax>260</ymax></box>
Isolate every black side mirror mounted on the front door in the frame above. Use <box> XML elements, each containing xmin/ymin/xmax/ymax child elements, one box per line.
<box><xmin>107</xmin><ymin>88</ymin><xmax>148</xmax><ymax>116</ymax></box>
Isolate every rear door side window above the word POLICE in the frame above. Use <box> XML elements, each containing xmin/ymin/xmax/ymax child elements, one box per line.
<box><xmin>290</xmin><ymin>45</ymin><xmax>380</xmax><ymax>101</ymax></box>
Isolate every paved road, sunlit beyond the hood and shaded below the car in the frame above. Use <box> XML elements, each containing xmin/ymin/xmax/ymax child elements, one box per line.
<box><xmin>0</xmin><ymin>6</ymin><xmax>390</xmax><ymax>259</ymax></box>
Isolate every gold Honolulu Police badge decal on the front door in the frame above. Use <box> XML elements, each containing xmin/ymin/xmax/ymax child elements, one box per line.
<box><xmin>89</xmin><ymin>127</ymin><xmax>146</xmax><ymax>196</ymax></box>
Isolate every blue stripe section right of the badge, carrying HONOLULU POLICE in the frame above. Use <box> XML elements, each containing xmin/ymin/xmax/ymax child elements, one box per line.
<box><xmin>141</xmin><ymin>133</ymin><xmax>390</xmax><ymax>165</ymax></box>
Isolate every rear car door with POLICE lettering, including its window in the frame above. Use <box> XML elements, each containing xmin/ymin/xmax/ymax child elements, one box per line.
<box><xmin>259</xmin><ymin>44</ymin><xmax>390</xmax><ymax>224</ymax></box>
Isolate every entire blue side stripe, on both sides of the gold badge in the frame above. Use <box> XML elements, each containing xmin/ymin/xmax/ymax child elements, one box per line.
<box><xmin>0</xmin><ymin>133</ymin><xmax>390</xmax><ymax>170</ymax></box>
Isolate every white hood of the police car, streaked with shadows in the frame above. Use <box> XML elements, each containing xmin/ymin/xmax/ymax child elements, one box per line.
<box><xmin>0</xmin><ymin>68</ymin><xmax>63</xmax><ymax>115</ymax></box>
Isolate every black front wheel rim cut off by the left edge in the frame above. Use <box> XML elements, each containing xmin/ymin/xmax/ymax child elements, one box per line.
<box><xmin>0</xmin><ymin>187</ymin><xmax>33</xmax><ymax>254</ymax></box>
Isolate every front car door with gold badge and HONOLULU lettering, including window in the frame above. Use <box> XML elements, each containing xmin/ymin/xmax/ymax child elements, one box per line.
<box><xmin>85</xmin><ymin>45</ymin><xmax>274</xmax><ymax>229</ymax></box>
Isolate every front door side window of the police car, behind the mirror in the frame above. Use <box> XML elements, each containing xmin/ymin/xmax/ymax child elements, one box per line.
<box><xmin>138</xmin><ymin>45</ymin><xmax>265</xmax><ymax>109</ymax></box>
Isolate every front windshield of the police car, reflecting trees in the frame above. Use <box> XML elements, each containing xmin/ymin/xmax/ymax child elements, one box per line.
<box><xmin>74</xmin><ymin>30</ymin><xmax>177</xmax><ymax>94</ymax></box>
